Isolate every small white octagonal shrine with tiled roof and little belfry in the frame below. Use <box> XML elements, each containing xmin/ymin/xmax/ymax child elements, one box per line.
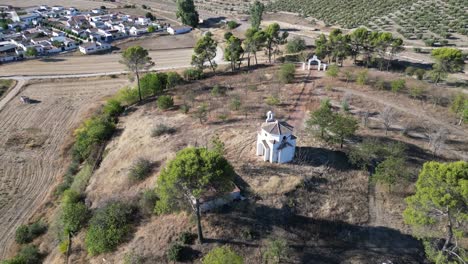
<box><xmin>257</xmin><ymin>111</ymin><xmax>296</xmax><ymax>163</ymax></box>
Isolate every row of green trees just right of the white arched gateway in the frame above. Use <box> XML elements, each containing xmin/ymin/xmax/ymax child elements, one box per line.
<box><xmin>315</xmin><ymin>28</ymin><xmax>403</xmax><ymax>70</ymax></box>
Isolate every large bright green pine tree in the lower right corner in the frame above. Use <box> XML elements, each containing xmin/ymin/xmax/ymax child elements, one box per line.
<box><xmin>403</xmin><ymin>161</ymin><xmax>468</xmax><ymax>263</ymax></box>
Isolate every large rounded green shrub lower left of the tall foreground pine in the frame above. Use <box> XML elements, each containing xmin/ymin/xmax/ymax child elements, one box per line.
<box><xmin>85</xmin><ymin>202</ymin><xmax>134</xmax><ymax>256</ymax></box>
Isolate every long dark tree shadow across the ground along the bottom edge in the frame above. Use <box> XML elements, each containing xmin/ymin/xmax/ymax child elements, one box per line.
<box><xmin>206</xmin><ymin>204</ymin><xmax>425</xmax><ymax>263</ymax></box>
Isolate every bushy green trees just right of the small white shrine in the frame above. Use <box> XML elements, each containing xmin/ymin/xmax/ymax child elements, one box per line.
<box><xmin>306</xmin><ymin>99</ymin><xmax>358</xmax><ymax>148</ymax></box>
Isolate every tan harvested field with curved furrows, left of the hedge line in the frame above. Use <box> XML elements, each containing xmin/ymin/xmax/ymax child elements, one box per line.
<box><xmin>0</xmin><ymin>78</ymin><xmax>127</xmax><ymax>256</ymax></box>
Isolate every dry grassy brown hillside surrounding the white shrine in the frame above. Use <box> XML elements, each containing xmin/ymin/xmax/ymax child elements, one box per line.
<box><xmin>33</xmin><ymin>63</ymin><xmax>466</xmax><ymax>263</ymax></box>
